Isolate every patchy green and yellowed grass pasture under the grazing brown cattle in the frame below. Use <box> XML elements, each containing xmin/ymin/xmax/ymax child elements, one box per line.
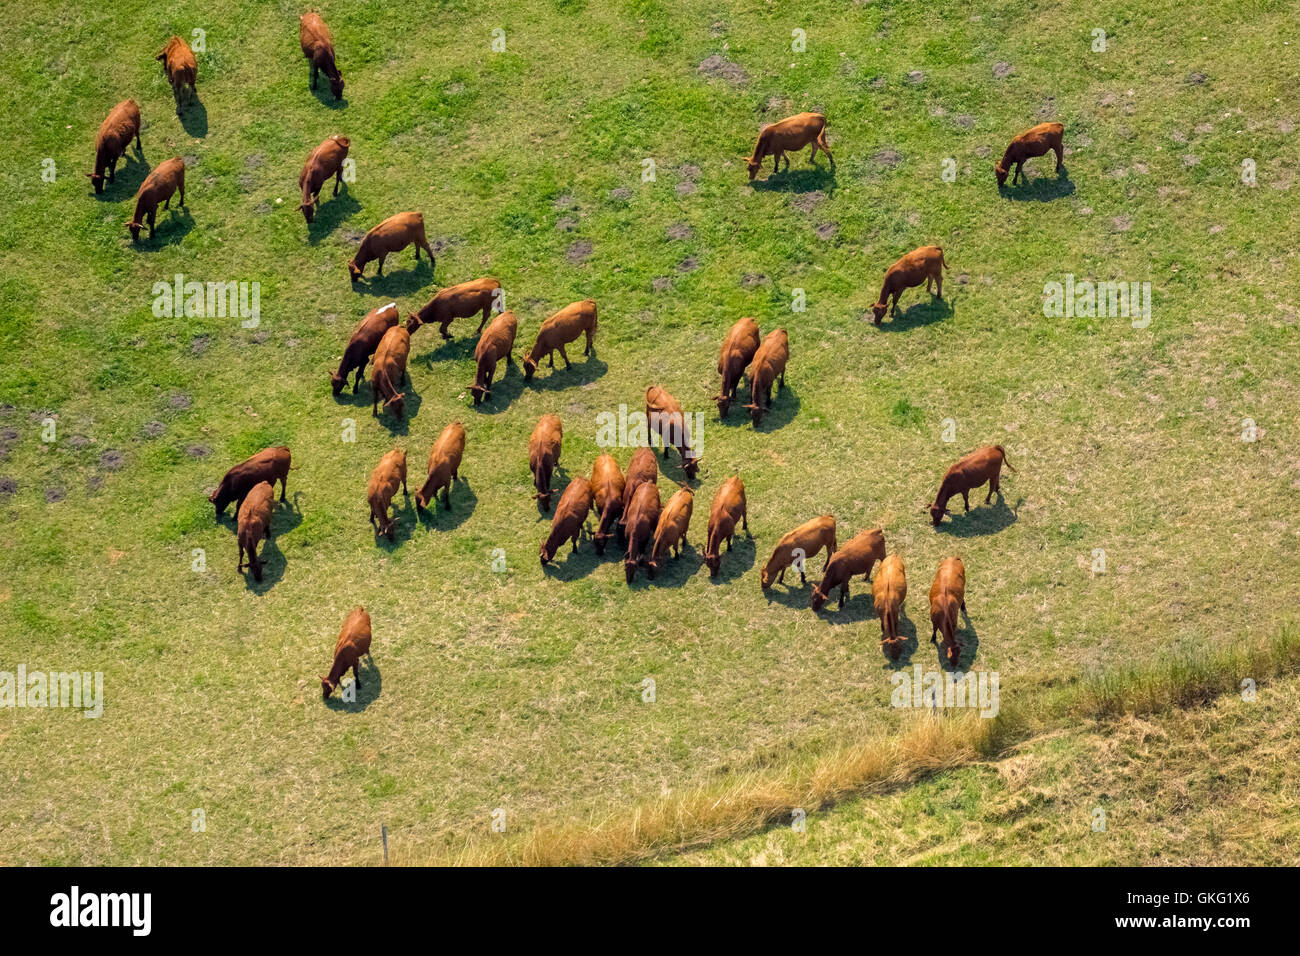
<box><xmin>0</xmin><ymin>0</ymin><xmax>1300</xmax><ymax>865</ymax></box>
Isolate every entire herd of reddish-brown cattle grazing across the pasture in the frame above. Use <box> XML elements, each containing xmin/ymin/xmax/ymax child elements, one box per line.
<box><xmin>87</xmin><ymin>13</ymin><xmax>1063</xmax><ymax>698</ymax></box>
